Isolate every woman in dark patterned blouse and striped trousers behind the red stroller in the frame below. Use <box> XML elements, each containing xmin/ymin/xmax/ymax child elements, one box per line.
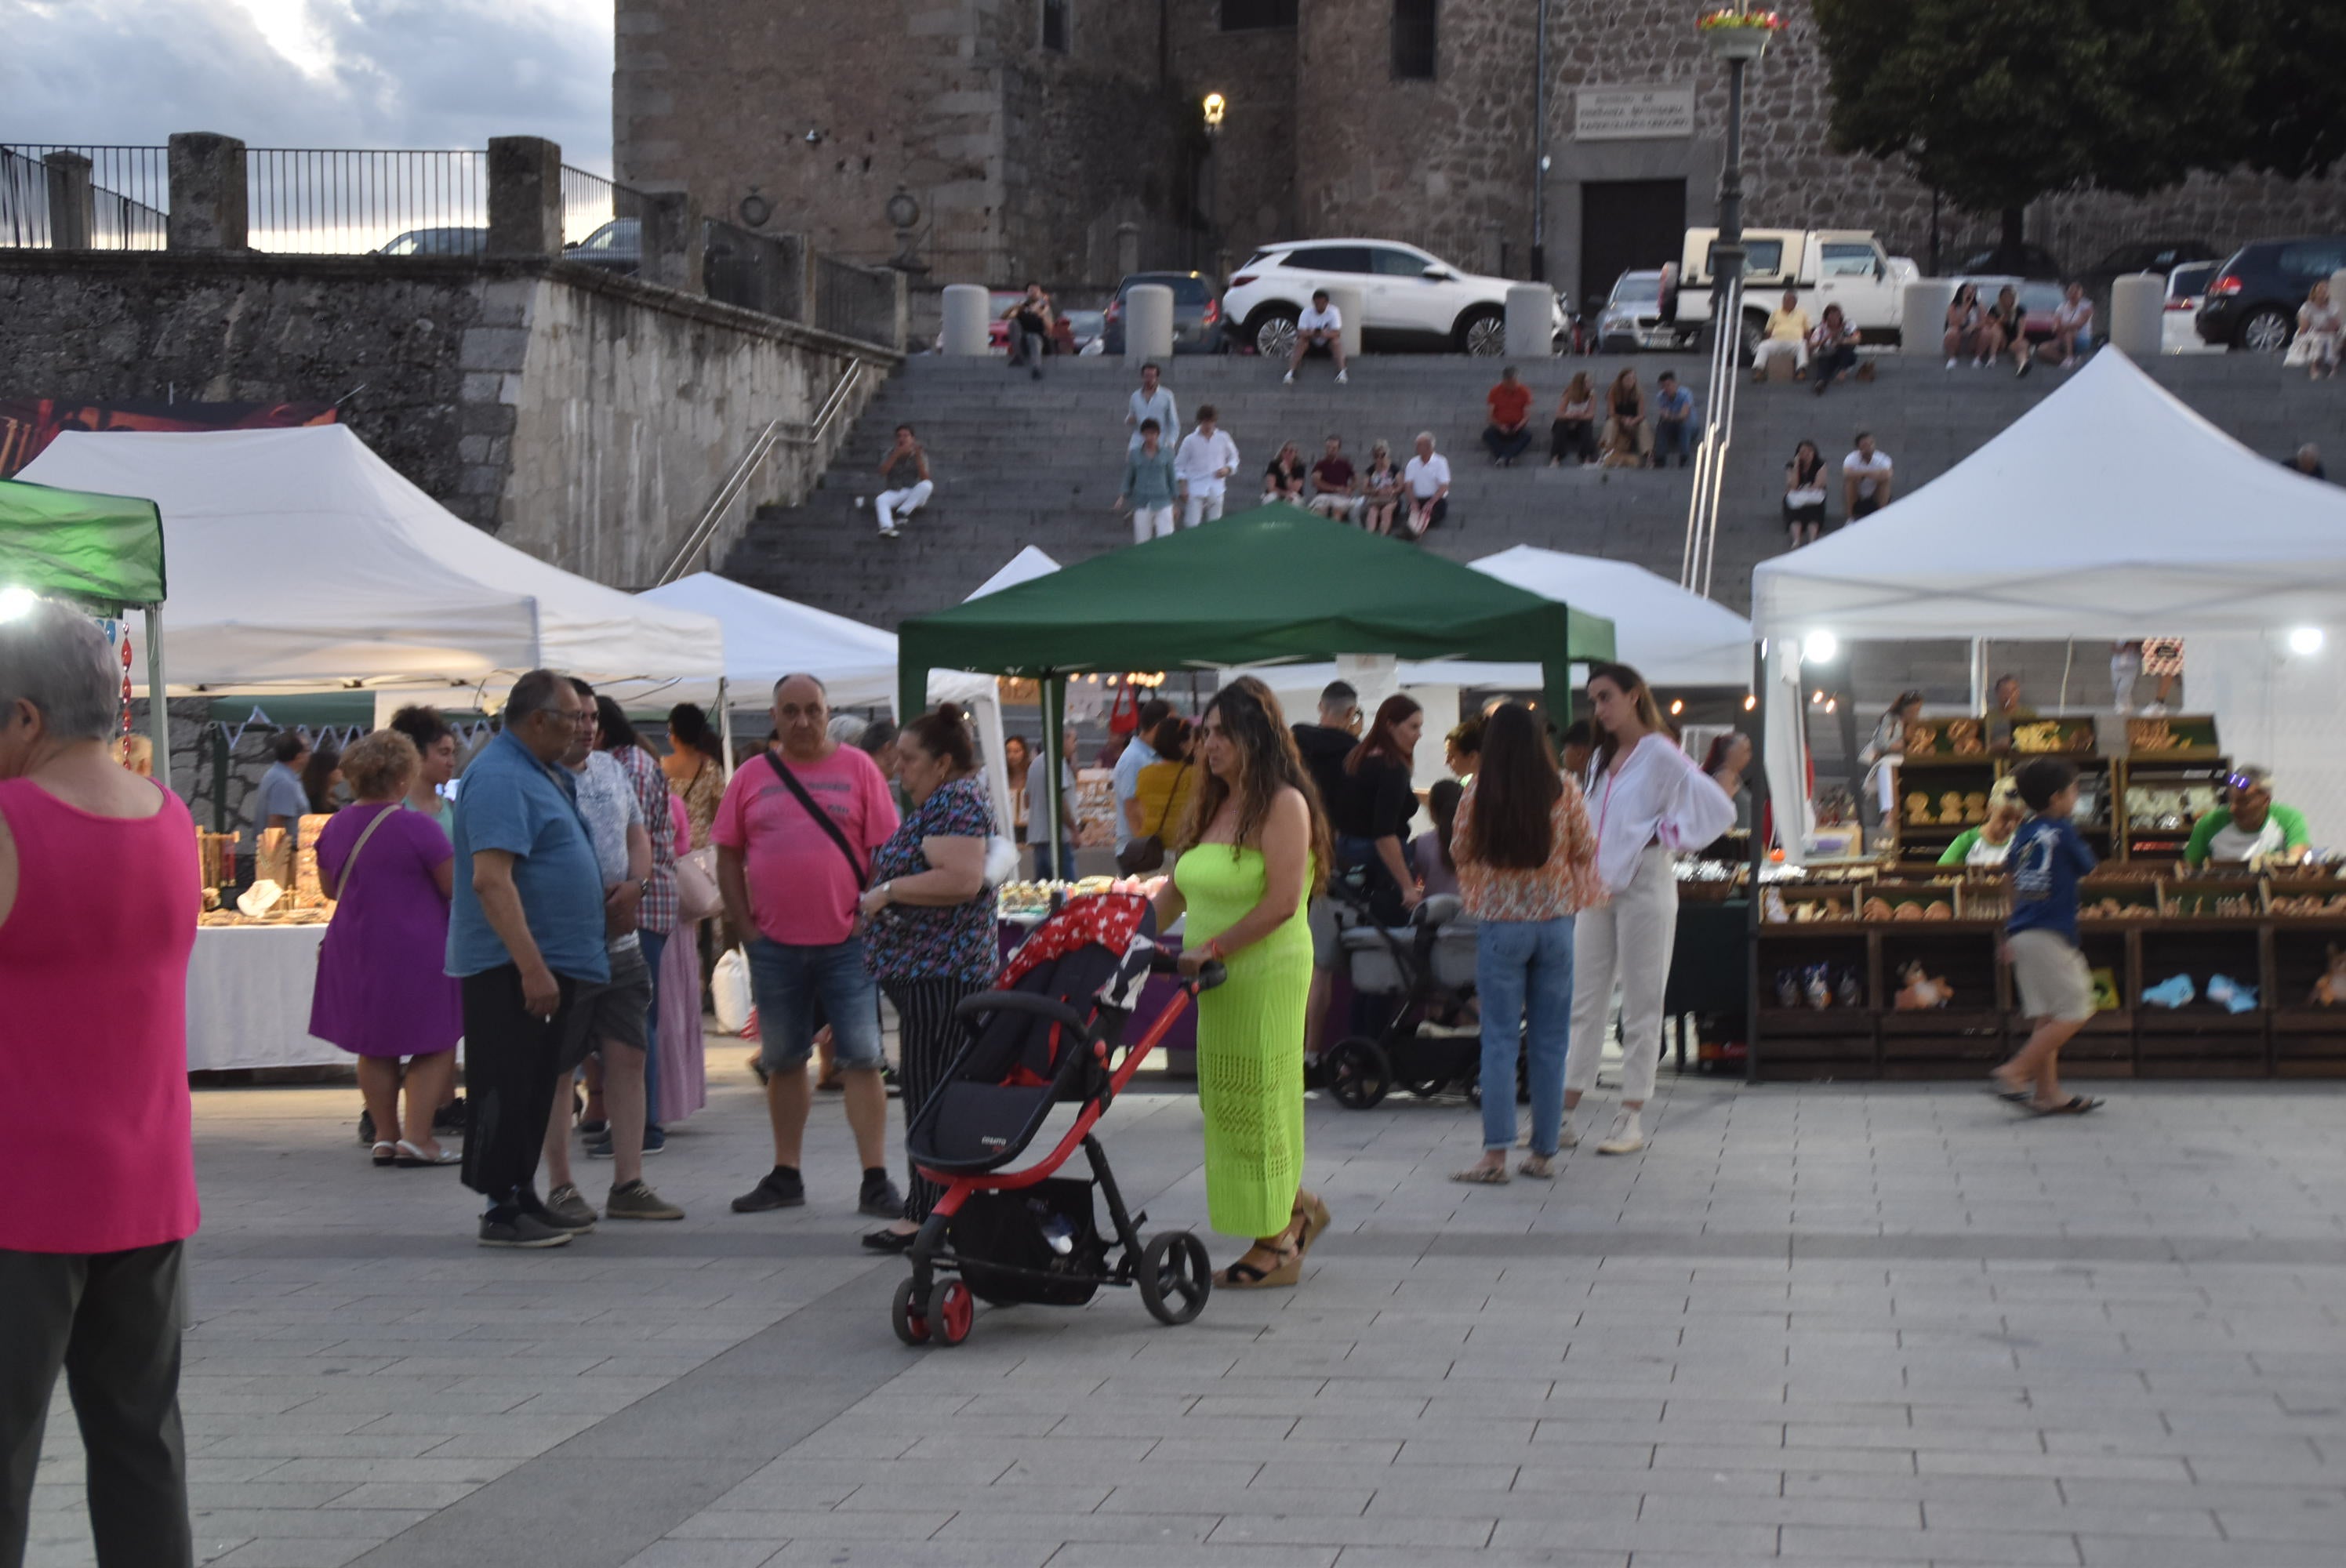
<box><xmin>863</xmin><ymin>704</ymin><xmax>1002</xmax><ymax>1251</ymax></box>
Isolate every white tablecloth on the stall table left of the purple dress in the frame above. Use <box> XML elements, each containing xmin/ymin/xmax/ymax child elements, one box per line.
<box><xmin>187</xmin><ymin>925</ymin><xmax>352</xmax><ymax>1073</ymax></box>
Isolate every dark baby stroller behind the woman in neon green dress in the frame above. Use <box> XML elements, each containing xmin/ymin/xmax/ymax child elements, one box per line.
<box><xmin>1319</xmin><ymin>883</ymin><xmax>1483</xmax><ymax>1110</ymax></box>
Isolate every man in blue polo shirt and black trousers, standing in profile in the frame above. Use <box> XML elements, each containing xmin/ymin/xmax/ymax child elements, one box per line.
<box><xmin>448</xmin><ymin>669</ymin><xmax>610</xmax><ymax>1247</ymax></box>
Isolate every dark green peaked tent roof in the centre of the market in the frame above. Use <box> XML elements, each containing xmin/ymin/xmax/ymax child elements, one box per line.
<box><xmin>896</xmin><ymin>505</ymin><xmax>1614</xmax><ymax>713</ymax></box>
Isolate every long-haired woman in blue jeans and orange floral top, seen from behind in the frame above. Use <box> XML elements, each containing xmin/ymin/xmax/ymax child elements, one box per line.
<box><xmin>1450</xmin><ymin>702</ymin><xmax>1605</xmax><ymax>1185</ymax></box>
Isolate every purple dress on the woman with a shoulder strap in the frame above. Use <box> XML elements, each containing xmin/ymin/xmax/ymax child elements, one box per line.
<box><xmin>310</xmin><ymin>805</ymin><xmax>464</xmax><ymax>1056</ymax></box>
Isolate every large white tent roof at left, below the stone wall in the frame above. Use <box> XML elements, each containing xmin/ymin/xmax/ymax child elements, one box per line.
<box><xmin>21</xmin><ymin>425</ymin><xmax>725</xmax><ymax>692</ymax></box>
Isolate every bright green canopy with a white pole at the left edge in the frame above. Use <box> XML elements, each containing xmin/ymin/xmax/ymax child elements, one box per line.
<box><xmin>0</xmin><ymin>479</ymin><xmax>171</xmax><ymax>789</ymax></box>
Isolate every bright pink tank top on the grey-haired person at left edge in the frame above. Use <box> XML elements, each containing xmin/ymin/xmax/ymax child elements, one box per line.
<box><xmin>0</xmin><ymin>779</ymin><xmax>197</xmax><ymax>1254</ymax></box>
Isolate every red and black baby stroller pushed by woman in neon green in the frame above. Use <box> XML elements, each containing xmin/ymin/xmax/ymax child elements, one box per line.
<box><xmin>889</xmin><ymin>892</ymin><xmax>1222</xmax><ymax>1345</ymax></box>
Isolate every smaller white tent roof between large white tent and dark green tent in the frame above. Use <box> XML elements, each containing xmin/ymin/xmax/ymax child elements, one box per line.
<box><xmin>636</xmin><ymin>573</ymin><xmax>995</xmax><ymax>706</ymax></box>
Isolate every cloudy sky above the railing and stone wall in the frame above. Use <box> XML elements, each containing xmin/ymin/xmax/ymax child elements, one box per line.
<box><xmin>0</xmin><ymin>0</ymin><xmax>612</xmax><ymax>174</ymax></box>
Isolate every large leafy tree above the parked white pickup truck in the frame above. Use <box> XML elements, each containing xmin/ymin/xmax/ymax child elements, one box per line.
<box><xmin>1814</xmin><ymin>0</ymin><xmax>2242</xmax><ymax>263</ymax></box>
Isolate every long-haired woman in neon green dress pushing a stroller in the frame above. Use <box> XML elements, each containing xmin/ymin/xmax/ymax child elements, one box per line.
<box><xmin>1157</xmin><ymin>676</ymin><xmax>1330</xmax><ymax>1289</ymax></box>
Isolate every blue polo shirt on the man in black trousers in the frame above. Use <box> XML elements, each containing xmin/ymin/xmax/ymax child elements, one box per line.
<box><xmin>448</xmin><ymin>732</ymin><xmax>610</xmax><ymax>981</ymax></box>
